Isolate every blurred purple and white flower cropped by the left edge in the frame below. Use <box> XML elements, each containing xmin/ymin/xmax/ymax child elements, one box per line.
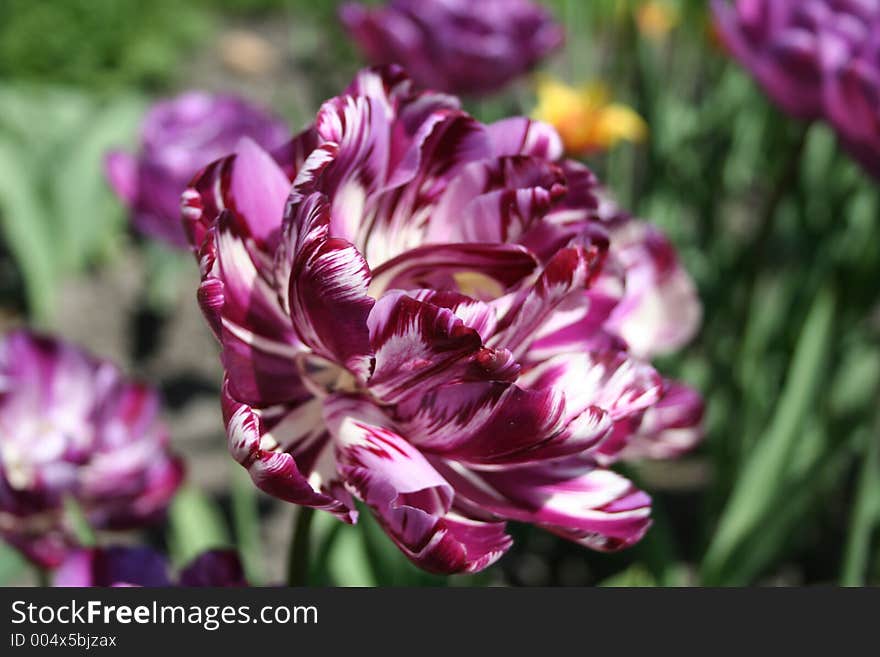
<box><xmin>0</xmin><ymin>331</ymin><xmax>183</xmax><ymax>567</ymax></box>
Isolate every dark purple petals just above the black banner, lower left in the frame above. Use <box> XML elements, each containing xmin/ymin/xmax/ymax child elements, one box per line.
<box><xmin>52</xmin><ymin>546</ymin><xmax>248</xmax><ymax>587</ymax></box>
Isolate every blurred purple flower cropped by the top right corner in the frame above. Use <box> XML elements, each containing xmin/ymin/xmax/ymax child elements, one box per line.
<box><xmin>712</xmin><ymin>0</ymin><xmax>880</xmax><ymax>176</ymax></box>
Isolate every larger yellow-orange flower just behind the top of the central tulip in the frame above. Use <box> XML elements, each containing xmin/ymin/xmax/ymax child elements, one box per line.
<box><xmin>532</xmin><ymin>77</ymin><xmax>648</xmax><ymax>155</ymax></box>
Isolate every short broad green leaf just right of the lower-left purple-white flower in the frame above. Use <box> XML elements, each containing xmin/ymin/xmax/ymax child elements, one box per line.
<box><xmin>168</xmin><ymin>486</ymin><xmax>232</xmax><ymax>567</ymax></box>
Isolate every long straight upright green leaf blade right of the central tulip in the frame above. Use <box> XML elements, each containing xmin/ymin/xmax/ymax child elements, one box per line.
<box><xmin>703</xmin><ymin>288</ymin><xmax>835</xmax><ymax>584</ymax></box>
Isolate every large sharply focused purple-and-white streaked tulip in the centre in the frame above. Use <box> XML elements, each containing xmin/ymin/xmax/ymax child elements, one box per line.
<box><xmin>184</xmin><ymin>68</ymin><xmax>699</xmax><ymax>573</ymax></box>
